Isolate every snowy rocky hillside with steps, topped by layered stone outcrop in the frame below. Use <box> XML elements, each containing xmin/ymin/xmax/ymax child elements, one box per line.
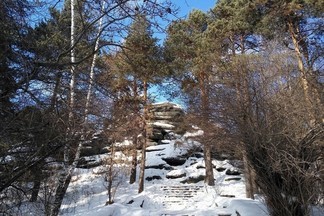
<box><xmin>53</xmin><ymin>103</ymin><xmax>323</xmax><ymax>216</ymax></box>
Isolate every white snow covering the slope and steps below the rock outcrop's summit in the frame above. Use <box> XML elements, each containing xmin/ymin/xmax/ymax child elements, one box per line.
<box><xmin>55</xmin><ymin>134</ymin><xmax>274</xmax><ymax>216</ymax></box>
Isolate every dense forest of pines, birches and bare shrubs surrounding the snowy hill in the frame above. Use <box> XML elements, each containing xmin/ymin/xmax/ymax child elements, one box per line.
<box><xmin>0</xmin><ymin>0</ymin><xmax>324</xmax><ymax>216</ymax></box>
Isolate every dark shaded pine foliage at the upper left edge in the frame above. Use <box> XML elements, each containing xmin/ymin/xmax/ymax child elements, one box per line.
<box><xmin>0</xmin><ymin>0</ymin><xmax>34</xmax><ymax>118</ymax></box>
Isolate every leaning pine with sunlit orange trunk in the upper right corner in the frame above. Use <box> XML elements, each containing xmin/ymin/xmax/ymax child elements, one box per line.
<box><xmin>255</xmin><ymin>0</ymin><xmax>324</xmax><ymax>127</ymax></box>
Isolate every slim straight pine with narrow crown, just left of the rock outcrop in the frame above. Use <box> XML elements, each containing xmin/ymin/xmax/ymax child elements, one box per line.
<box><xmin>124</xmin><ymin>14</ymin><xmax>163</xmax><ymax>193</ymax></box>
